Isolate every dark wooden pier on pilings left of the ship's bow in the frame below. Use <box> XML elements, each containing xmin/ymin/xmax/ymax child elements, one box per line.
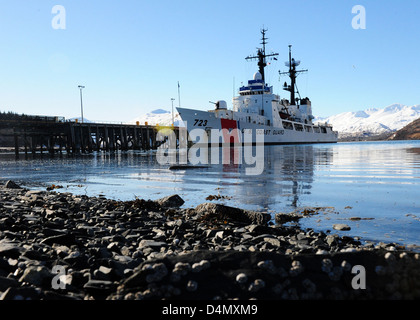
<box><xmin>0</xmin><ymin>117</ymin><xmax>179</xmax><ymax>157</ymax></box>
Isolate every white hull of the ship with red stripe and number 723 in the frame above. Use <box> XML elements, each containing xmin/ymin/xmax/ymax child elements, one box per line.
<box><xmin>177</xmin><ymin>108</ymin><xmax>337</xmax><ymax>145</ymax></box>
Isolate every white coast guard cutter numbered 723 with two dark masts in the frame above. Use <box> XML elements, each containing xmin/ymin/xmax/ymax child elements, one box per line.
<box><xmin>177</xmin><ymin>29</ymin><xmax>337</xmax><ymax>144</ymax></box>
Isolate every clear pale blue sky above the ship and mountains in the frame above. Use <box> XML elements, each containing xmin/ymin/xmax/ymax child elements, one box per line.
<box><xmin>0</xmin><ymin>0</ymin><xmax>420</xmax><ymax>122</ymax></box>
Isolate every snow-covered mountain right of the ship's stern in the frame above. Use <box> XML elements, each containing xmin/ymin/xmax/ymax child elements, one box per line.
<box><xmin>314</xmin><ymin>103</ymin><xmax>420</xmax><ymax>138</ymax></box>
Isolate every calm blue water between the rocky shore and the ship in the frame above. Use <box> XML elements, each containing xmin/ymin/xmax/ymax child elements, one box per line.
<box><xmin>0</xmin><ymin>141</ymin><xmax>420</xmax><ymax>245</ymax></box>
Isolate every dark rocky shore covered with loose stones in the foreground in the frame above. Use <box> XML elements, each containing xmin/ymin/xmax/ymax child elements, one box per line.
<box><xmin>0</xmin><ymin>182</ymin><xmax>420</xmax><ymax>300</ymax></box>
